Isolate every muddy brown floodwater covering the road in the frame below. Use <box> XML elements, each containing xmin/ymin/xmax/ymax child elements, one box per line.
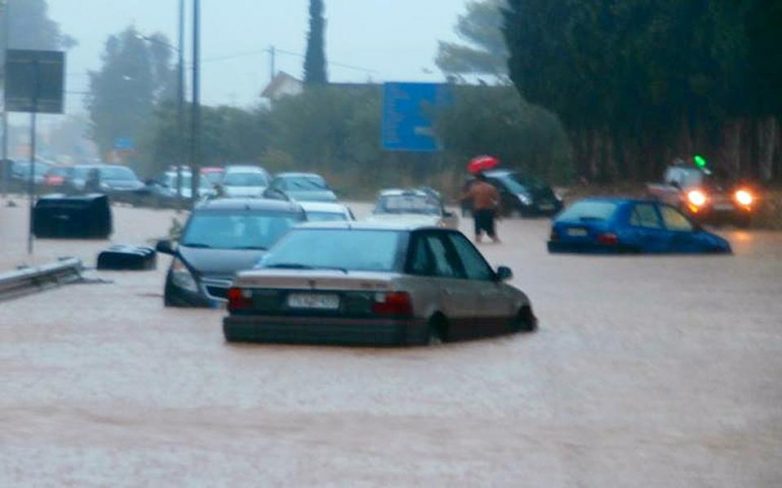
<box><xmin>0</xmin><ymin>201</ymin><xmax>782</xmax><ymax>487</ymax></box>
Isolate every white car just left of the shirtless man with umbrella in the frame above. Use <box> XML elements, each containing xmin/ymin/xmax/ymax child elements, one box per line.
<box><xmin>367</xmin><ymin>189</ymin><xmax>459</xmax><ymax>229</ymax></box>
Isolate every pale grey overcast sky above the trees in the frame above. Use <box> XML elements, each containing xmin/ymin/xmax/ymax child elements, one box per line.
<box><xmin>48</xmin><ymin>0</ymin><xmax>467</xmax><ymax>112</ymax></box>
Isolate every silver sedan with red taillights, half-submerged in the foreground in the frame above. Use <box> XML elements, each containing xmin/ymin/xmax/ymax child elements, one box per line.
<box><xmin>223</xmin><ymin>222</ymin><xmax>537</xmax><ymax>345</ymax></box>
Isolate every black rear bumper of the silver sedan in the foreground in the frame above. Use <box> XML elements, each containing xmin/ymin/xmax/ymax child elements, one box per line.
<box><xmin>223</xmin><ymin>315</ymin><xmax>429</xmax><ymax>346</ymax></box>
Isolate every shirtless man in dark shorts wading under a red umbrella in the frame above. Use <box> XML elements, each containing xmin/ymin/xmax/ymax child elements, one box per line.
<box><xmin>462</xmin><ymin>156</ymin><xmax>500</xmax><ymax>243</ymax></box>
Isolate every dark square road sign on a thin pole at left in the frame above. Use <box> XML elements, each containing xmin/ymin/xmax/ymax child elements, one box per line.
<box><xmin>5</xmin><ymin>49</ymin><xmax>65</xmax><ymax>254</ymax></box>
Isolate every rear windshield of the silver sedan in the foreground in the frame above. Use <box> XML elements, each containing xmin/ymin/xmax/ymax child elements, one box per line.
<box><xmin>260</xmin><ymin>229</ymin><xmax>401</xmax><ymax>271</ymax></box>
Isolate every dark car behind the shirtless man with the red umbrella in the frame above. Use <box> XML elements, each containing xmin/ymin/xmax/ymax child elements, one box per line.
<box><xmin>462</xmin><ymin>169</ymin><xmax>564</xmax><ymax>217</ymax></box>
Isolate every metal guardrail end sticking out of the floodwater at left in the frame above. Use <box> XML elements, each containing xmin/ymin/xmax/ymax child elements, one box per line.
<box><xmin>0</xmin><ymin>258</ymin><xmax>84</xmax><ymax>302</ymax></box>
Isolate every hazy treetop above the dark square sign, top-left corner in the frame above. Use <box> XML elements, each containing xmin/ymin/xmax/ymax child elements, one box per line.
<box><xmin>0</xmin><ymin>0</ymin><xmax>76</xmax><ymax>50</ymax></box>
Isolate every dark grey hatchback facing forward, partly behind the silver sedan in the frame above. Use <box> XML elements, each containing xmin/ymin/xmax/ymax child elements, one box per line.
<box><xmin>157</xmin><ymin>198</ymin><xmax>306</xmax><ymax>307</ymax></box>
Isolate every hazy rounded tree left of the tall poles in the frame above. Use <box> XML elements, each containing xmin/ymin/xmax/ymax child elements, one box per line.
<box><xmin>87</xmin><ymin>27</ymin><xmax>175</xmax><ymax>155</ymax></box>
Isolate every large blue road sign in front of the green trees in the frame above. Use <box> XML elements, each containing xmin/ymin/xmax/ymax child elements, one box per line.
<box><xmin>381</xmin><ymin>83</ymin><xmax>451</xmax><ymax>152</ymax></box>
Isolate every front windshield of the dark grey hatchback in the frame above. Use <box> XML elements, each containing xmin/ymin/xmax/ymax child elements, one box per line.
<box><xmin>182</xmin><ymin>211</ymin><xmax>301</xmax><ymax>249</ymax></box>
